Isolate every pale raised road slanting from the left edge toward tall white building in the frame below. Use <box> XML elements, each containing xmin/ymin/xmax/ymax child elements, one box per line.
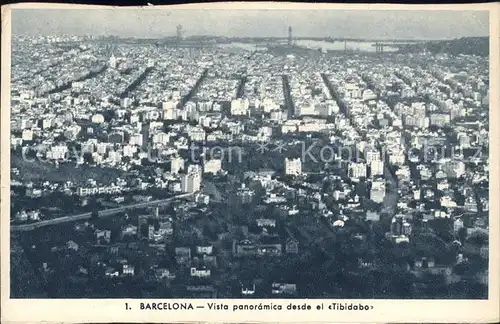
<box><xmin>10</xmin><ymin>193</ymin><xmax>193</xmax><ymax>231</ymax></box>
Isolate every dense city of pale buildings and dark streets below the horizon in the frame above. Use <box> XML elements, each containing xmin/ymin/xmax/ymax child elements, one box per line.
<box><xmin>10</xmin><ymin>9</ymin><xmax>489</xmax><ymax>299</ymax></box>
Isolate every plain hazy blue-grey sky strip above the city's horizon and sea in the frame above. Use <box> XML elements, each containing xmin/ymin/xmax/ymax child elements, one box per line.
<box><xmin>12</xmin><ymin>8</ymin><xmax>489</xmax><ymax>39</ymax></box>
